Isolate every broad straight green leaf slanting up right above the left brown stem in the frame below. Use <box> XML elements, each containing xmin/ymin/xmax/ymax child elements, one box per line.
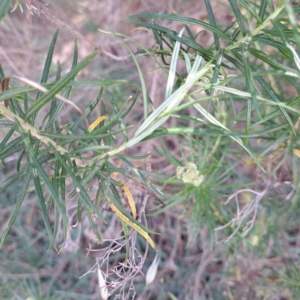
<box><xmin>26</xmin><ymin>51</ymin><xmax>98</xmax><ymax>120</ymax></box>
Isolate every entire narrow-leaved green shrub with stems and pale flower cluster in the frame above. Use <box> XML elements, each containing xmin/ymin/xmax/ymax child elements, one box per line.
<box><xmin>0</xmin><ymin>0</ymin><xmax>300</xmax><ymax>299</ymax></box>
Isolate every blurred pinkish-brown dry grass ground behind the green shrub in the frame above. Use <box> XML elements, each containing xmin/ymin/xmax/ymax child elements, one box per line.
<box><xmin>0</xmin><ymin>0</ymin><xmax>292</xmax><ymax>300</ymax></box>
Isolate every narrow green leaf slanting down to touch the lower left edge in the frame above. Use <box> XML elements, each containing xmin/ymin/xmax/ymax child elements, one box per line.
<box><xmin>0</xmin><ymin>166</ymin><xmax>31</xmax><ymax>249</ymax></box>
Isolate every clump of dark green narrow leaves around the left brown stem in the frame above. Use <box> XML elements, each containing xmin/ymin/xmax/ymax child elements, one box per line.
<box><xmin>0</xmin><ymin>31</ymin><xmax>159</xmax><ymax>252</ymax></box>
